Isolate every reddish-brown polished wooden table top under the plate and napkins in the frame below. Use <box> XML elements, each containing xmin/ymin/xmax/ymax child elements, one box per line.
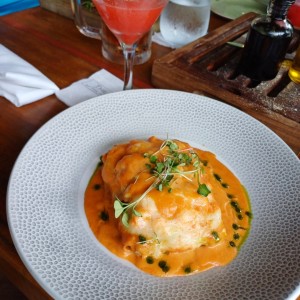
<box><xmin>0</xmin><ymin>7</ymin><xmax>300</xmax><ymax>299</ymax></box>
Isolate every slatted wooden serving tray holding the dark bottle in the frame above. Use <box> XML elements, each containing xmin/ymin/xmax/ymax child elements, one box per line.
<box><xmin>152</xmin><ymin>13</ymin><xmax>300</xmax><ymax>153</ymax></box>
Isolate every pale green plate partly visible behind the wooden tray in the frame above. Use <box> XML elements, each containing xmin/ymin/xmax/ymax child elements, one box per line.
<box><xmin>211</xmin><ymin>0</ymin><xmax>267</xmax><ymax>20</ymax></box>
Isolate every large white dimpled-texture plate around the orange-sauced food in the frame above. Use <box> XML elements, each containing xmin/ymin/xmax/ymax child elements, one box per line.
<box><xmin>7</xmin><ymin>90</ymin><xmax>300</xmax><ymax>300</ymax></box>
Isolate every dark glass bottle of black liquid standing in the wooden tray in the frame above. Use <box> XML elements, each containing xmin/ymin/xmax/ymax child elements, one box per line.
<box><xmin>239</xmin><ymin>0</ymin><xmax>295</xmax><ymax>81</ymax></box>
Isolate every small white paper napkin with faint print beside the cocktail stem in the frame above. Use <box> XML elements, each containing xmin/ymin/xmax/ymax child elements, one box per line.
<box><xmin>55</xmin><ymin>69</ymin><xmax>123</xmax><ymax>106</ymax></box>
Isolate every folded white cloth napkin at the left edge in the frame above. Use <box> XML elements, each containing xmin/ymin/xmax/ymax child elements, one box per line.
<box><xmin>0</xmin><ymin>44</ymin><xmax>59</xmax><ymax>107</ymax></box>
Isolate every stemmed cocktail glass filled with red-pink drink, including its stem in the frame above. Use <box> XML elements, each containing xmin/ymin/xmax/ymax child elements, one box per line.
<box><xmin>93</xmin><ymin>0</ymin><xmax>168</xmax><ymax>90</ymax></box>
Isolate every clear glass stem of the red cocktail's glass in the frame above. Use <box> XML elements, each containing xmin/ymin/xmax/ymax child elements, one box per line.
<box><xmin>121</xmin><ymin>43</ymin><xmax>137</xmax><ymax>91</ymax></box>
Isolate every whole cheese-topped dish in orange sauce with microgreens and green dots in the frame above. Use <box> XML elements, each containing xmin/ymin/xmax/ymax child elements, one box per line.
<box><xmin>84</xmin><ymin>137</ymin><xmax>251</xmax><ymax>276</ymax></box>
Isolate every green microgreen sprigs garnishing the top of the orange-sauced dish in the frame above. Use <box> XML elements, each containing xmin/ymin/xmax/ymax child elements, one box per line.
<box><xmin>114</xmin><ymin>139</ymin><xmax>211</xmax><ymax>227</ymax></box>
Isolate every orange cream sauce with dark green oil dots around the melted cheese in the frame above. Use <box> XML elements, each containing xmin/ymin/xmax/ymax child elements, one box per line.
<box><xmin>84</xmin><ymin>137</ymin><xmax>251</xmax><ymax>276</ymax></box>
